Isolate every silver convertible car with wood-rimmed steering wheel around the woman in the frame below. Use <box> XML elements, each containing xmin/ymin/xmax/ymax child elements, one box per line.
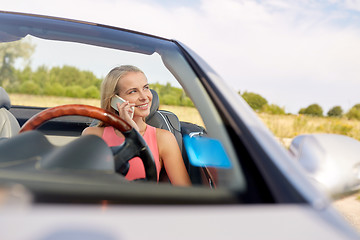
<box><xmin>0</xmin><ymin>11</ymin><xmax>359</xmax><ymax>240</ymax></box>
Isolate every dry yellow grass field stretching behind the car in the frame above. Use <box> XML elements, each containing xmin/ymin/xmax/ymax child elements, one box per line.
<box><xmin>10</xmin><ymin>94</ymin><xmax>360</xmax><ymax>140</ymax></box>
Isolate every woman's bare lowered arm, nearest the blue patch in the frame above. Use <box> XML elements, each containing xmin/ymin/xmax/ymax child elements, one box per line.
<box><xmin>156</xmin><ymin>128</ymin><xmax>191</xmax><ymax>186</ymax></box>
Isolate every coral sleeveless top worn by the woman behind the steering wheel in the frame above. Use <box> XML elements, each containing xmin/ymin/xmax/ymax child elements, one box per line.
<box><xmin>102</xmin><ymin>125</ymin><xmax>161</xmax><ymax>181</ymax></box>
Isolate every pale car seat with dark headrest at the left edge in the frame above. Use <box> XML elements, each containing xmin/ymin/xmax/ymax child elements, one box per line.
<box><xmin>0</xmin><ymin>87</ymin><xmax>20</xmax><ymax>138</ymax></box>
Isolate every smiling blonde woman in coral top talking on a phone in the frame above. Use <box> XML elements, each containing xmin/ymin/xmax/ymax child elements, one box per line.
<box><xmin>83</xmin><ymin>65</ymin><xmax>191</xmax><ymax>186</ymax></box>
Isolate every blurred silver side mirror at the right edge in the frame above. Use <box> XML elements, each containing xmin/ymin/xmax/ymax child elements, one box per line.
<box><xmin>289</xmin><ymin>134</ymin><xmax>360</xmax><ymax>198</ymax></box>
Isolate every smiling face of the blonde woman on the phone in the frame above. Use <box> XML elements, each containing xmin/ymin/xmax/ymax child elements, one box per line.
<box><xmin>117</xmin><ymin>72</ymin><xmax>152</xmax><ymax>117</ymax></box>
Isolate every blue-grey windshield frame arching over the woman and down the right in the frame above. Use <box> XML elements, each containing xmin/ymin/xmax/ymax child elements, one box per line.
<box><xmin>0</xmin><ymin>12</ymin><xmax>250</xmax><ymax>200</ymax></box>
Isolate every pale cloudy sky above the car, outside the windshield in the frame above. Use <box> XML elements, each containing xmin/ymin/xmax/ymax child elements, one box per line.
<box><xmin>0</xmin><ymin>0</ymin><xmax>360</xmax><ymax>114</ymax></box>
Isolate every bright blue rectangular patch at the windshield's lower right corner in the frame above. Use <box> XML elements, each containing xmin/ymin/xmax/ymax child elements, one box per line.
<box><xmin>183</xmin><ymin>135</ymin><xmax>231</xmax><ymax>168</ymax></box>
